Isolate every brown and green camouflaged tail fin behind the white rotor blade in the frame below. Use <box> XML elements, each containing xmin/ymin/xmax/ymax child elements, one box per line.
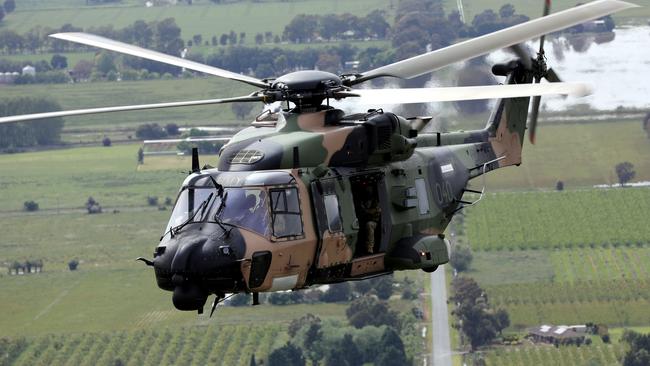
<box><xmin>486</xmin><ymin>65</ymin><xmax>533</xmax><ymax>167</ymax></box>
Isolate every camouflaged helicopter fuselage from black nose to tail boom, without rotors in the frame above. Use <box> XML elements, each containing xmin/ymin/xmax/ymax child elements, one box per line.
<box><xmin>153</xmin><ymin>95</ymin><xmax>520</xmax><ymax>311</ymax></box>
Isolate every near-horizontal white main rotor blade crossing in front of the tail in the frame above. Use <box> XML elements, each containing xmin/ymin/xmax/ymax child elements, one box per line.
<box><xmin>338</xmin><ymin>83</ymin><xmax>590</xmax><ymax>105</ymax></box>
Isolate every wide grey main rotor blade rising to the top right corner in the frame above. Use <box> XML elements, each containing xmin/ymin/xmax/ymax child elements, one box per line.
<box><xmin>352</xmin><ymin>0</ymin><xmax>638</xmax><ymax>84</ymax></box>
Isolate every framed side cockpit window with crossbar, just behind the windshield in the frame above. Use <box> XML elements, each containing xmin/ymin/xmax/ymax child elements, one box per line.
<box><xmin>271</xmin><ymin>188</ymin><xmax>302</xmax><ymax>238</ymax></box>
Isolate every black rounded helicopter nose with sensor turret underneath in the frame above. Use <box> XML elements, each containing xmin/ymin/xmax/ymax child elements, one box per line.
<box><xmin>153</xmin><ymin>237</ymin><xmax>241</xmax><ymax>312</ymax></box>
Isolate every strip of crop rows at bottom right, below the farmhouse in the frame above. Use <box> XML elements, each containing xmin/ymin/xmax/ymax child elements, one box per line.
<box><xmin>485</xmin><ymin>343</ymin><xmax>625</xmax><ymax>366</ymax></box>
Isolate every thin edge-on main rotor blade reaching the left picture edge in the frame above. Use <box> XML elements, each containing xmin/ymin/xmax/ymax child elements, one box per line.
<box><xmin>0</xmin><ymin>96</ymin><xmax>264</xmax><ymax>124</ymax></box>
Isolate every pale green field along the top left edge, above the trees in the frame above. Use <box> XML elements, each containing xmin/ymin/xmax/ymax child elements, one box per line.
<box><xmin>3</xmin><ymin>0</ymin><xmax>390</xmax><ymax>45</ymax></box>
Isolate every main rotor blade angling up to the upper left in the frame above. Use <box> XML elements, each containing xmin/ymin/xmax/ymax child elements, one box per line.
<box><xmin>50</xmin><ymin>33</ymin><xmax>268</xmax><ymax>88</ymax></box>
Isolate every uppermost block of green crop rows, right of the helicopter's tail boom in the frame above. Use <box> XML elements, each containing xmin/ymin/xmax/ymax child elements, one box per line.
<box><xmin>465</xmin><ymin>188</ymin><xmax>650</xmax><ymax>250</ymax></box>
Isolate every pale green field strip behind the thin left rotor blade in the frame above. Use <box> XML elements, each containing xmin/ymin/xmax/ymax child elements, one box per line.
<box><xmin>3</xmin><ymin>77</ymin><xmax>262</xmax><ymax>131</ymax></box>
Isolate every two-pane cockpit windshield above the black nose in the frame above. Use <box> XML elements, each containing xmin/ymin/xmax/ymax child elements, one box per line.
<box><xmin>166</xmin><ymin>186</ymin><xmax>271</xmax><ymax>236</ymax></box>
